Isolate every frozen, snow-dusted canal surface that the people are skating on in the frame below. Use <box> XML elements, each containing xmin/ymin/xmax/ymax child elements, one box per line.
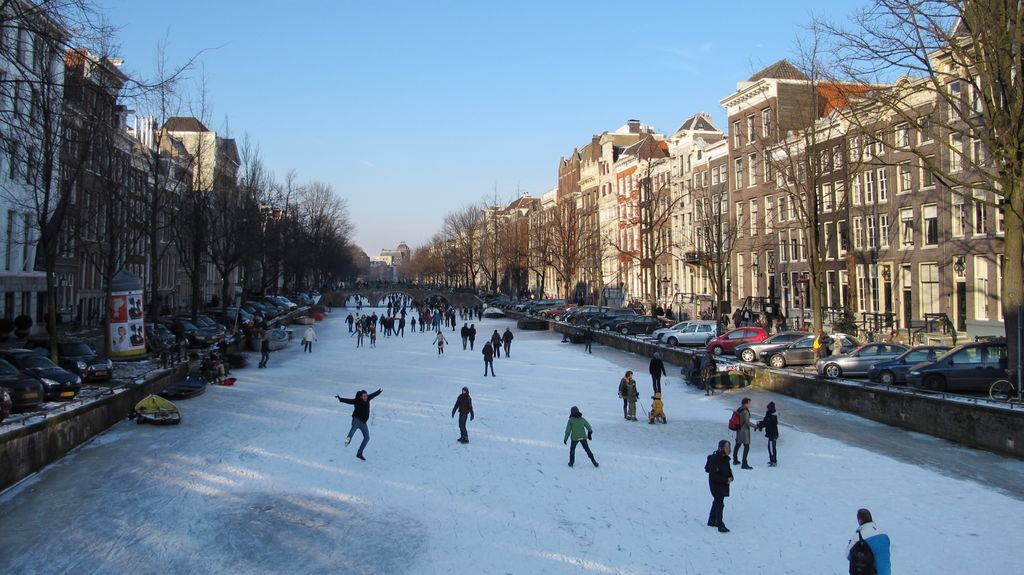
<box><xmin>0</xmin><ymin>310</ymin><xmax>1024</xmax><ymax>574</ymax></box>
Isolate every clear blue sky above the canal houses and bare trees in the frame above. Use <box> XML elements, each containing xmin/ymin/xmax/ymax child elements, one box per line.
<box><xmin>98</xmin><ymin>0</ymin><xmax>865</xmax><ymax>255</ymax></box>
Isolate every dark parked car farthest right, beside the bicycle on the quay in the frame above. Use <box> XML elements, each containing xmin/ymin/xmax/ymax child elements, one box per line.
<box><xmin>906</xmin><ymin>340</ymin><xmax>1007</xmax><ymax>392</ymax></box>
